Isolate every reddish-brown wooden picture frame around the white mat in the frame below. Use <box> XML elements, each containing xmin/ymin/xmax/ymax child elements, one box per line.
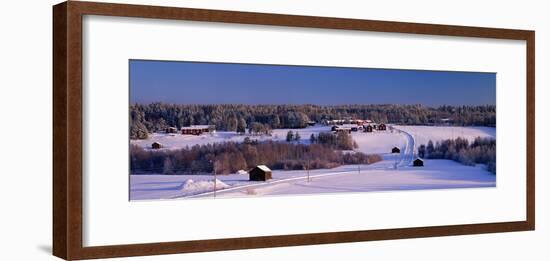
<box><xmin>53</xmin><ymin>1</ymin><xmax>535</xmax><ymax>260</ymax></box>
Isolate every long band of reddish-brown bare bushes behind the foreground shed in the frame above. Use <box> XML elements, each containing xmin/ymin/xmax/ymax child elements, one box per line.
<box><xmin>130</xmin><ymin>134</ymin><xmax>382</xmax><ymax>174</ymax></box>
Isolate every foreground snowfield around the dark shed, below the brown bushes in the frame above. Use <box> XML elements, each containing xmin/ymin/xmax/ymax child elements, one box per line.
<box><xmin>130</xmin><ymin>160</ymin><xmax>496</xmax><ymax>200</ymax></box>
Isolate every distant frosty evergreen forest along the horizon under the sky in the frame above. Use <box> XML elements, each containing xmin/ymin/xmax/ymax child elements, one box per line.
<box><xmin>130</xmin><ymin>103</ymin><xmax>496</xmax><ymax>139</ymax></box>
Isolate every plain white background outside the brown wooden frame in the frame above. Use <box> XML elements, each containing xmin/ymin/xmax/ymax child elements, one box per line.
<box><xmin>0</xmin><ymin>0</ymin><xmax>550</xmax><ymax>261</ymax></box>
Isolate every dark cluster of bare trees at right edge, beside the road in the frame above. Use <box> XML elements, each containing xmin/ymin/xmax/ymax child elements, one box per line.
<box><xmin>418</xmin><ymin>137</ymin><xmax>496</xmax><ymax>174</ymax></box>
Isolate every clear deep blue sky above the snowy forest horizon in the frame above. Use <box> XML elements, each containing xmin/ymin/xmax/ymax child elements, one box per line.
<box><xmin>130</xmin><ymin>60</ymin><xmax>496</xmax><ymax>106</ymax></box>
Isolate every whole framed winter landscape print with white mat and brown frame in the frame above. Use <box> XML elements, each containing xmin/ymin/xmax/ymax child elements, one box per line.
<box><xmin>53</xmin><ymin>1</ymin><xmax>535</xmax><ymax>260</ymax></box>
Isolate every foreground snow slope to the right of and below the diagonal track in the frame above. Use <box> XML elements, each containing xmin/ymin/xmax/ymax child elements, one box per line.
<box><xmin>211</xmin><ymin>160</ymin><xmax>496</xmax><ymax>197</ymax></box>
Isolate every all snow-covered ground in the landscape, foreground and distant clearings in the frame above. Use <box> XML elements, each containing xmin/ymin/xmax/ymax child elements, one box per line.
<box><xmin>130</xmin><ymin>125</ymin><xmax>496</xmax><ymax>200</ymax></box>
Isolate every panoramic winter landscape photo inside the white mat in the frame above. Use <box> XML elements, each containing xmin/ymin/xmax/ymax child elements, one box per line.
<box><xmin>129</xmin><ymin>60</ymin><xmax>496</xmax><ymax>200</ymax></box>
